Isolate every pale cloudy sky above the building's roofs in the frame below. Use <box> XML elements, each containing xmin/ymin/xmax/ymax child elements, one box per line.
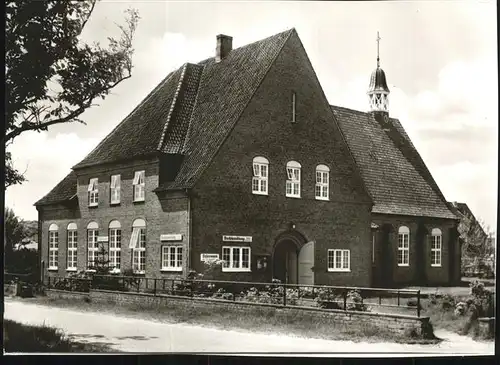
<box><xmin>6</xmin><ymin>0</ymin><xmax>498</xmax><ymax>230</ymax></box>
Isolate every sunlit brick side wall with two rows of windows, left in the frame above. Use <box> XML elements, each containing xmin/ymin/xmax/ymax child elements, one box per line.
<box><xmin>41</xmin><ymin>156</ymin><xmax>189</xmax><ymax>277</ymax></box>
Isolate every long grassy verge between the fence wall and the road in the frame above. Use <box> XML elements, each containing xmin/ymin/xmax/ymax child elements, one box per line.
<box><xmin>21</xmin><ymin>297</ymin><xmax>439</xmax><ymax>343</ymax></box>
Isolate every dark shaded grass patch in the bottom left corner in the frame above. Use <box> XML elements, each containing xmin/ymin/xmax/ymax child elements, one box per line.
<box><xmin>3</xmin><ymin>319</ymin><xmax>117</xmax><ymax>352</ymax></box>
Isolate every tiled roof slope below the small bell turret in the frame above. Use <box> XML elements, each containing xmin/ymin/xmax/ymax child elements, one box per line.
<box><xmin>332</xmin><ymin>106</ymin><xmax>457</xmax><ymax>219</ymax></box>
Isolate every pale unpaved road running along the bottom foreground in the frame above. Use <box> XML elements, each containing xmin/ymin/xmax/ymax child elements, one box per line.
<box><xmin>4</xmin><ymin>298</ymin><xmax>494</xmax><ymax>356</ymax></box>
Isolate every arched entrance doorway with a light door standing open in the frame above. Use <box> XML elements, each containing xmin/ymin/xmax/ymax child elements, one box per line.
<box><xmin>273</xmin><ymin>230</ymin><xmax>314</xmax><ymax>284</ymax></box>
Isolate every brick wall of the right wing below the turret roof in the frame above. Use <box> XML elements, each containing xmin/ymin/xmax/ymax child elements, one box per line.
<box><xmin>373</xmin><ymin>214</ymin><xmax>458</xmax><ymax>286</ymax></box>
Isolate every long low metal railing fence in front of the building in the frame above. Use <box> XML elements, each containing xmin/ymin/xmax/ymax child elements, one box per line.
<box><xmin>47</xmin><ymin>275</ymin><xmax>421</xmax><ymax>317</ymax></box>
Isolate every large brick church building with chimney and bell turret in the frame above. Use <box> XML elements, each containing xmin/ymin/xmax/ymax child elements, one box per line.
<box><xmin>35</xmin><ymin>29</ymin><xmax>460</xmax><ymax>286</ymax></box>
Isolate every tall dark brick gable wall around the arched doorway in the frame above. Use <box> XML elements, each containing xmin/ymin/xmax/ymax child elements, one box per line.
<box><xmin>191</xmin><ymin>31</ymin><xmax>371</xmax><ymax>286</ymax></box>
